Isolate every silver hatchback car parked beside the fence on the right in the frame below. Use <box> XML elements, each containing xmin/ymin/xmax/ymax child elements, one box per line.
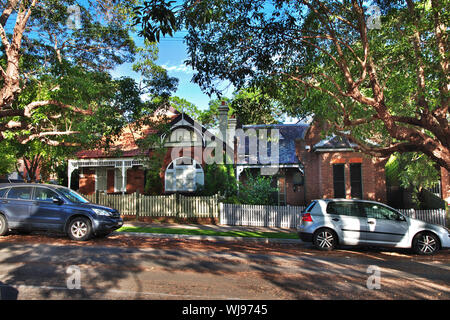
<box><xmin>297</xmin><ymin>199</ymin><xmax>450</xmax><ymax>255</ymax></box>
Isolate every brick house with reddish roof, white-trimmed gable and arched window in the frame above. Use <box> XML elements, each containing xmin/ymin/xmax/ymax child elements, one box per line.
<box><xmin>68</xmin><ymin>108</ymin><xmax>233</xmax><ymax>195</ymax></box>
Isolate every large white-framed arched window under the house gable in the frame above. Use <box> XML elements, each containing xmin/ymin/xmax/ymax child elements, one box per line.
<box><xmin>165</xmin><ymin>157</ymin><xmax>205</xmax><ymax>192</ymax></box>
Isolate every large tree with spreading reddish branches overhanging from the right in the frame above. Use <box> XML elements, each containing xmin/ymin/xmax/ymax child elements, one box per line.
<box><xmin>137</xmin><ymin>0</ymin><xmax>450</xmax><ymax>170</ymax></box>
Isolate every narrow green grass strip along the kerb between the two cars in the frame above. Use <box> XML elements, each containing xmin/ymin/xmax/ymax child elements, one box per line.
<box><xmin>117</xmin><ymin>227</ymin><xmax>298</xmax><ymax>239</ymax></box>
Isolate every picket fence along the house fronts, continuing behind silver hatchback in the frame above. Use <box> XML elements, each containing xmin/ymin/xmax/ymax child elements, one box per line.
<box><xmin>85</xmin><ymin>193</ymin><xmax>446</xmax><ymax>228</ymax></box>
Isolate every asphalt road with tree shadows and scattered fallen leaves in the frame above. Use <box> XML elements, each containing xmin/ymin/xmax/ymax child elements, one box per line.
<box><xmin>0</xmin><ymin>235</ymin><xmax>450</xmax><ymax>300</ymax></box>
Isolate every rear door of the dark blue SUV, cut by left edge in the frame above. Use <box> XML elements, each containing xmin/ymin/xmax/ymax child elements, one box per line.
<box><xmin>1</xmin><ymin>186</ymin><xmax>33</xmax><ymax>229</ymax></box>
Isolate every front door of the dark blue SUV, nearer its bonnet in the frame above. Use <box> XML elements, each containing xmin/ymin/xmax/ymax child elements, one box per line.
<box><xmin>30</xmin><ymin>187</ymin><xmax>64</xmax><ymax>230</ymax></box>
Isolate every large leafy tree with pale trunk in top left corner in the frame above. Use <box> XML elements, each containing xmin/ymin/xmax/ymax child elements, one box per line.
<box><xmin>0</xmin><ymin>0</ymin><xmax>135</xmax><ymax>145</ymax></box>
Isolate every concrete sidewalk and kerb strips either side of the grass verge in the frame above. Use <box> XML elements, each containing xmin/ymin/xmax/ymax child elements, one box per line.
<box><xmin>116</xmin><ymin>221</ymin><xmax>302</xmax><ymax>243</ymax></box>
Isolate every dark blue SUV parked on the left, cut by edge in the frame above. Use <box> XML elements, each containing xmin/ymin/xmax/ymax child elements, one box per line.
<box><xmin>0</xmin><ymin>183</ymin><xmax>123</xmax><ymax>241</ymax></box>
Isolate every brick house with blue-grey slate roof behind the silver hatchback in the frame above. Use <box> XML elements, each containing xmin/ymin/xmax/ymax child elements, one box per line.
<box><xmin>236</xmin><ymin>119</ymin><xmax>386</xmax><ymax>205</ymax></box>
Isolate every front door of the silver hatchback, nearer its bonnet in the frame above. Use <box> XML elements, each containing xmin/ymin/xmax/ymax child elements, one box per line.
<box><xmin>361</xmin><ymin>202</ymin><xmax>408</xmax><ymax>245</ymax></box>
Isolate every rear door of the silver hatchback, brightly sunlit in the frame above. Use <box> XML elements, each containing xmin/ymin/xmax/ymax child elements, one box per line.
<box><xmin>327</xmin><ymin>201</ymin><xmax>368</xmax><ymax>244</ymax></box>
